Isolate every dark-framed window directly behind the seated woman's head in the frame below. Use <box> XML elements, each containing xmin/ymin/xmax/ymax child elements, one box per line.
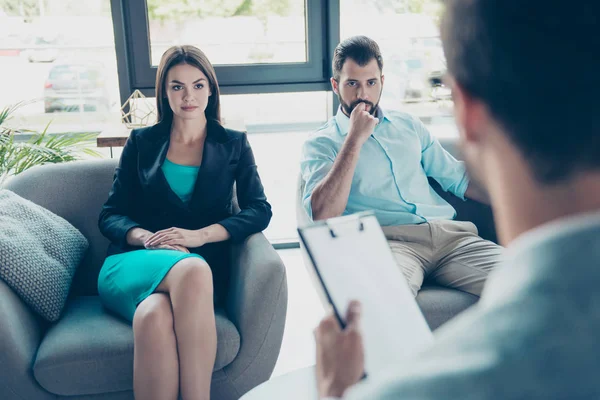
<box><xmin>123</xmin><ymin>0</ymin><xmax>328</xmax><ymax>95</ymax></box>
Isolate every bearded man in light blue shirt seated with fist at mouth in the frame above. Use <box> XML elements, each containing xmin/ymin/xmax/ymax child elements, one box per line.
<box><xmin>301</xmin><ymin>36</ymin><xmax>501</xmax><ymax>296</ymax></box>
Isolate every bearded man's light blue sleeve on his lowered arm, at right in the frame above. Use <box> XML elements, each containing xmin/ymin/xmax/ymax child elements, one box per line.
<box><xmin>413</xmin><ymin>118</ymin><xmax>469</xmax><ymax>200</ymax></box>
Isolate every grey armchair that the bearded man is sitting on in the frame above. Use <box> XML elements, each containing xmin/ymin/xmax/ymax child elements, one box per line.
<box><xmin>296</xmin><ymin>139</ymin><xmax>496</xmax><ymax>330</ymax></box>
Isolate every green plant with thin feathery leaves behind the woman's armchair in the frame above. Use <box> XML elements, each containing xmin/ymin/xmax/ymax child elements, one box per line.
<box><xmin>0</xmin><ymin>102</ymin><xmax>102</xmax><ymax>187</ymax></box>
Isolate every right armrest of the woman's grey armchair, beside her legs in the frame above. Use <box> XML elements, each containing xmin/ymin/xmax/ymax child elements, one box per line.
<box><xmin>225</xmin><ymin>233</ymin><xmax>287</xmax><ymax>393</ymax></box>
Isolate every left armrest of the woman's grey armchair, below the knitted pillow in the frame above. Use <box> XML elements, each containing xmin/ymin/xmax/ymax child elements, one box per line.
<box><xmin>0</xmin><ymin>280</ymin><xmax>55</xmax><ymax>400</ymax></box>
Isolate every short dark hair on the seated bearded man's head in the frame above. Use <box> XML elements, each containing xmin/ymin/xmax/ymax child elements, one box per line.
<box><xmin>333</xmin><ymin>36</ymin><xmax>383</xmax><ymax>81</ymax></box>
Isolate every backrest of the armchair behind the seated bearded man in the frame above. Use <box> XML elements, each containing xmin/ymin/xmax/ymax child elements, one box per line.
<box><xmin>296</xmin><ymin>138</ymin><xmax>497</xmax><ymax>242</ymax></box>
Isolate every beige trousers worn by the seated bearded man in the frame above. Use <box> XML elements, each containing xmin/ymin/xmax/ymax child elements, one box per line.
<box><xmin>382</xmin><ymin>220</ymin><xmax>503</xmax><ymax>296</ymax></box>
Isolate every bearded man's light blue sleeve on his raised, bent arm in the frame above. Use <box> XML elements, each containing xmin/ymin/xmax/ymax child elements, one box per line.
<box><xmin>300</xmin><ymin>136</ymin><xmax>336</xmax><ymax>219</ymax></box>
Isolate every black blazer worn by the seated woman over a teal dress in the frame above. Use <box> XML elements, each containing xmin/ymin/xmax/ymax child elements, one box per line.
<box><xmin>98</xmin><ymin>117</ymin><xmax>272</xmax><ymax>296</ymax></box>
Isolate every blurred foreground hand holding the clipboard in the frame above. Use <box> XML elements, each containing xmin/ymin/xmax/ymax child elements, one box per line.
<box><xmin>315</xmin><ymin>301</ymin><xmax>365</xmax><ymax>398</ymax></box>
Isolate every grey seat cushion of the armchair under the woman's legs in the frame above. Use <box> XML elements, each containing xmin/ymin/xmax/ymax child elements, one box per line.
<box><xmin>33</xmin><ymin>296</ymin><xmax>240</xmax><ymax>396</ymax></box>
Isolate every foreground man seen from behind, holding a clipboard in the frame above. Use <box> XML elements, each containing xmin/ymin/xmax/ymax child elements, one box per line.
<box><xmin>315</xmin><ymin>0</ymin><xmax>600</xmax><ymax>400</ymax></box>
